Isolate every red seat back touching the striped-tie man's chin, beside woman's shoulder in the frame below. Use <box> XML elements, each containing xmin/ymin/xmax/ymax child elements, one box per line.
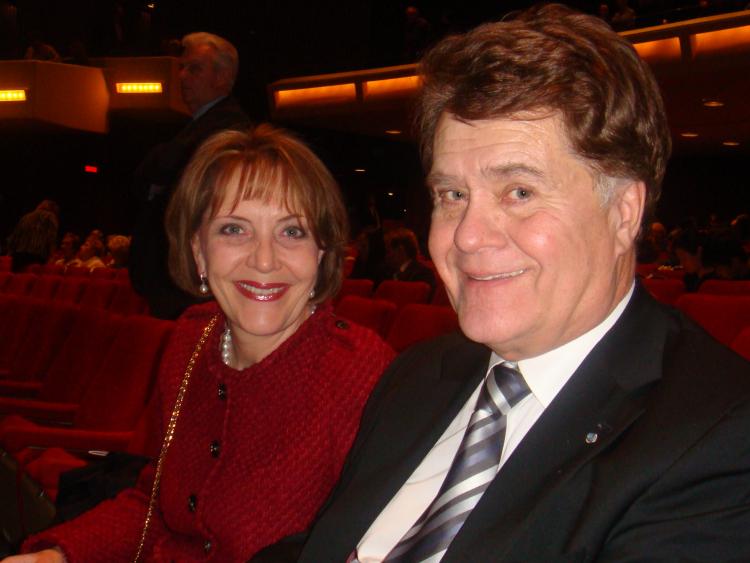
<box><xmin>386</xmin><ymin>303</ymin><xmax>458</xmax><ymax>352</ymax></box>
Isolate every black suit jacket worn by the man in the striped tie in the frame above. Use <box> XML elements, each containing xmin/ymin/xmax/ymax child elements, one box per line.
<box><xmin>300</xmin><ymin>288</ymin><xmax>750</xmax><ymax>563</ymax></box>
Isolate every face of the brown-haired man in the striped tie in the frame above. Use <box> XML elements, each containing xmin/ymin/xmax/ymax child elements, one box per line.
<box><xmin>428</xmin><ymin>114</ymin><xmax>645</xmax><ymax>360</ymax></box>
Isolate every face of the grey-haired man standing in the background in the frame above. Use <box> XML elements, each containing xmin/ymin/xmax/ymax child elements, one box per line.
<box><xmin>180</xmin><ymin>45</ymin><xmax>229</xmax><ymax>113</ymax></box>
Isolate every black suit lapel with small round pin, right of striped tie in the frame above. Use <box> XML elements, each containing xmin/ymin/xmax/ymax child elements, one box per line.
<box><xmin>444</xmin><ymin>290</ymin><xmax>665</xmax><ymax>563</ymax></box>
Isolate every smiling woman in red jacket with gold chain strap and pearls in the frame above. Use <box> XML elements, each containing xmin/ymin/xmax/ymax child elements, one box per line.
<box><xmin>14</xmin><ymin>126</ymin><xmax>393</xmax><ymax>563</ymax></box>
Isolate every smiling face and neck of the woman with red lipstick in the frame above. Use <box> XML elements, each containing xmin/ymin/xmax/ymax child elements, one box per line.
<box><xmin>192</xmin><ymin>176</ymin><xmax>323</xmax><ymax>367</ymax></box>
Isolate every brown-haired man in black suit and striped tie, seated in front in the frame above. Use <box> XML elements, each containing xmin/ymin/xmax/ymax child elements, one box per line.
<box><xmin>300</xmin><ymin>5</ymin><xmax>750</xmax><ymax>563</ymax></box>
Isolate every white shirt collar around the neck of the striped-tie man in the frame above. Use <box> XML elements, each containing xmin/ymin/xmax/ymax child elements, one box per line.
<box><xmin>490</xmin><ymin>283</ymin><xmax>635</xmax><ymax>408</ymax></box>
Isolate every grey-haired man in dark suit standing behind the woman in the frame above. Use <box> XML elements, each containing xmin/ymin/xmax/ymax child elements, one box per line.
<box><xmin>130</xmin><ymin>32</ymin><xmax>250</xmax><ymax>319</ymax></box>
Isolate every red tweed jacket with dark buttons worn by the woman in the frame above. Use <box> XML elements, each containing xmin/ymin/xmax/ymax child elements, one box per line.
<box><xmin>24</xmin><ymin>303</ymin><xmax>393</xmax><ymax>563</ymax></box>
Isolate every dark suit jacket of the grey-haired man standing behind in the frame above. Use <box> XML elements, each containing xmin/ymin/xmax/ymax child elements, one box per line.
<box><xmin>129</xmin><ymin>97</ymin><xmax>250</xmax><ymax>319</ymax></box>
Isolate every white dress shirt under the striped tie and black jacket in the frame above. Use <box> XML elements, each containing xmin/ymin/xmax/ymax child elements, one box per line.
<box><xmin>357</xmin><ymin>285</ymin><xmax>635</xmax><ymax>563</ymax></box>
